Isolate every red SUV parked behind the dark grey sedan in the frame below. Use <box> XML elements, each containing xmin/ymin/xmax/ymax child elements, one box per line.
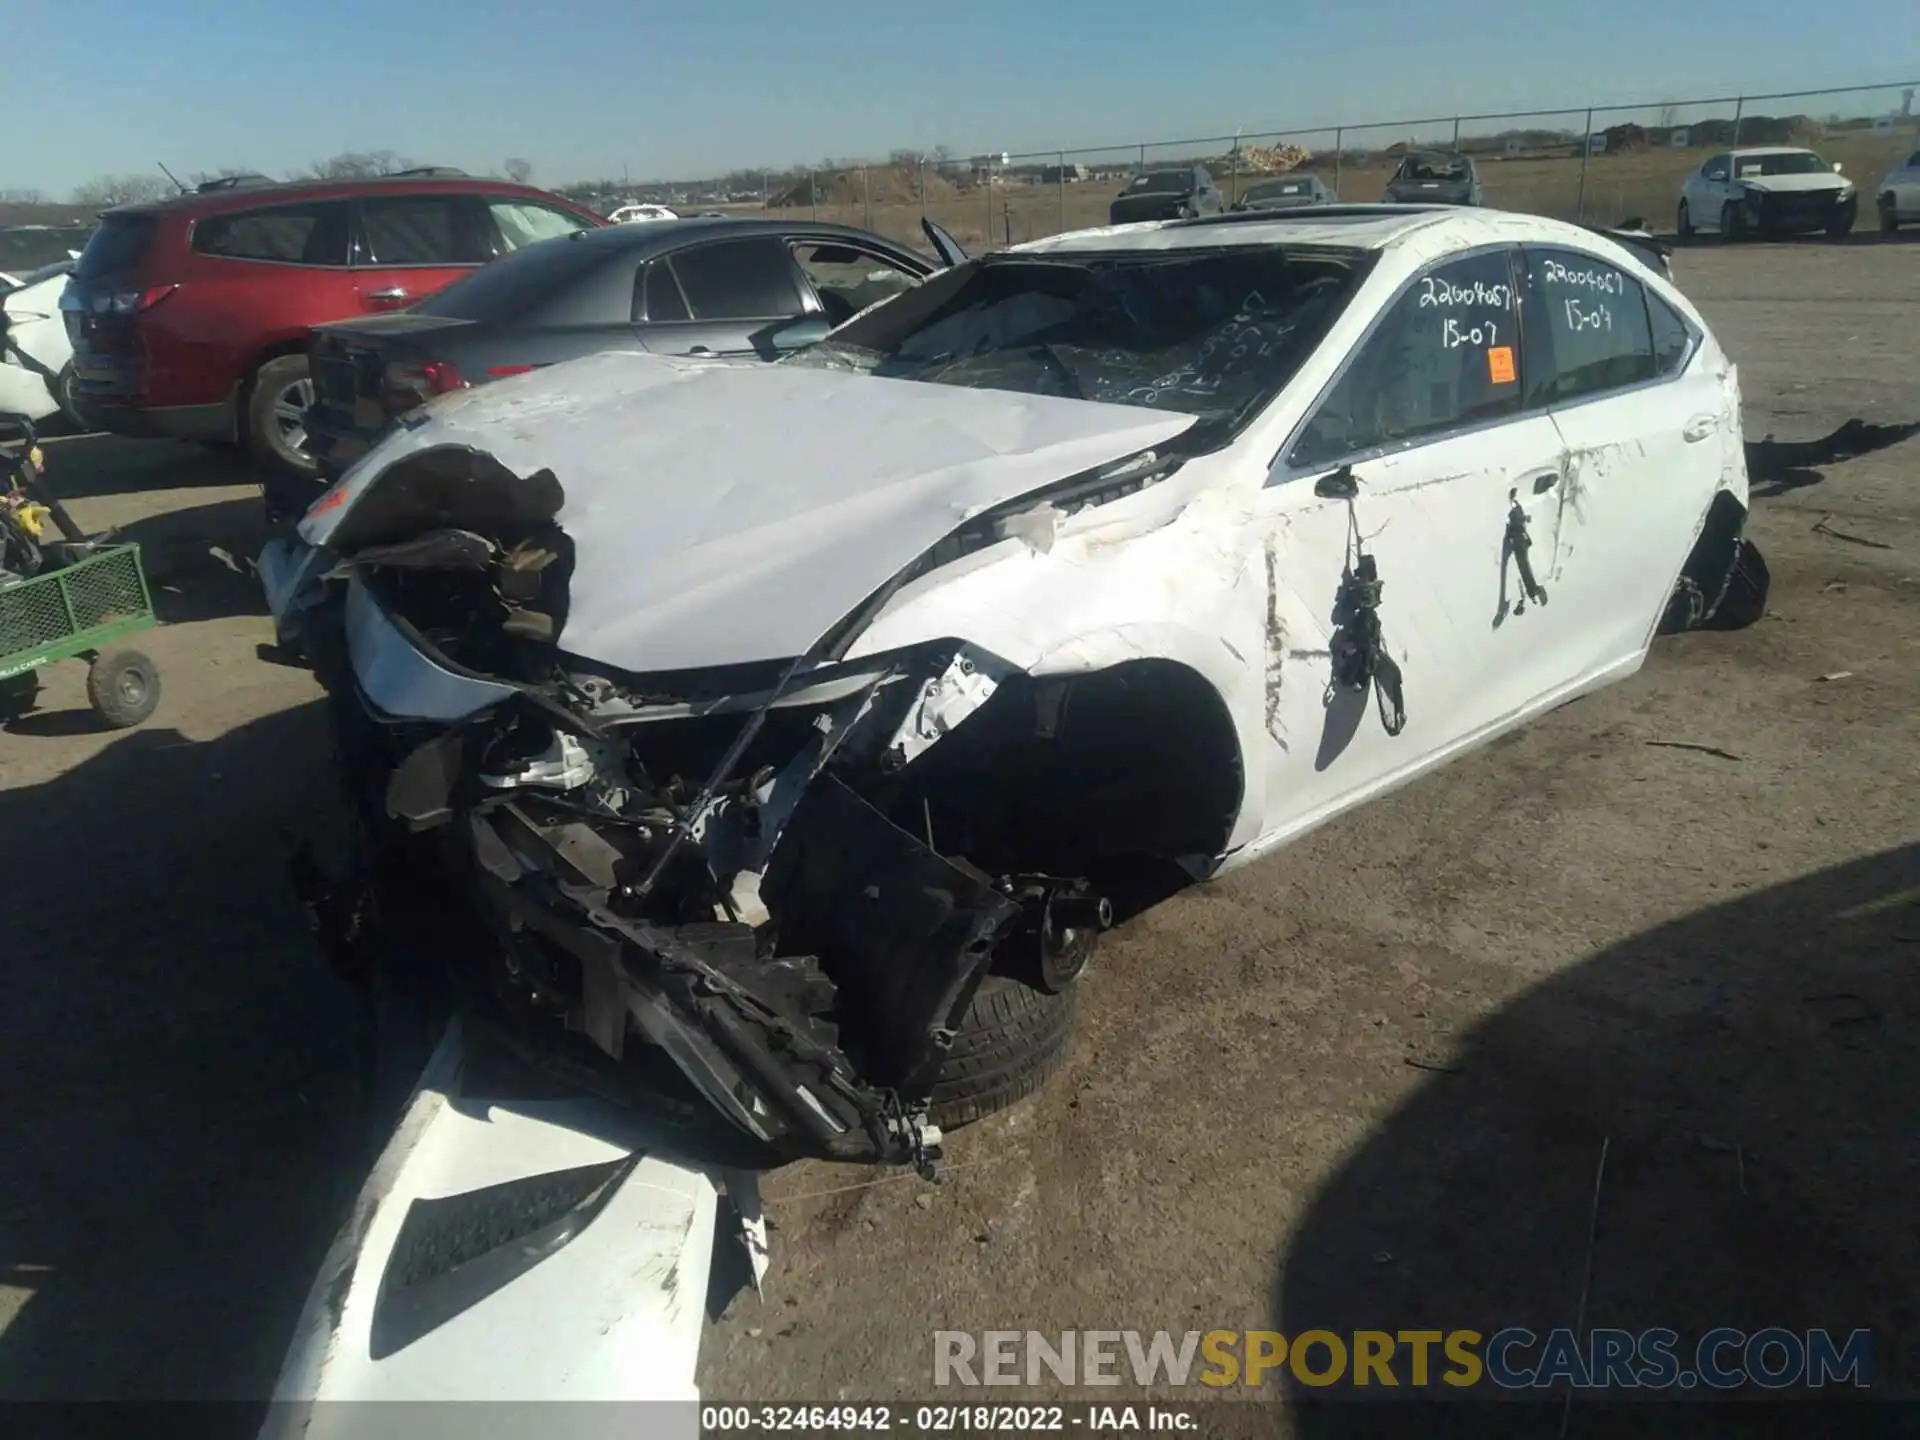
<box><xmin>60</xmin><ymin>171</ymin><xmax>605</xmax><ymax>474</ymax></box>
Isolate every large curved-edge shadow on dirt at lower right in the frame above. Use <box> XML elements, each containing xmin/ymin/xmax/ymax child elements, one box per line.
<box><xmin>1277</xmin><ymin>845</ymin><xmax>1920</xmax><ymax>1440</ymax></box>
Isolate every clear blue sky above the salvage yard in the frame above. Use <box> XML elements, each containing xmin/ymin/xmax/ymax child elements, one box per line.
<box><xmin>0</xmin><ymin>0</ymin><xmax>1920</xmax><ymax>198</ymax></box>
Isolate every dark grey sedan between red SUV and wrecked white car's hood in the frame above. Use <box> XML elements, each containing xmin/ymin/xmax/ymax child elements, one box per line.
<box><xmin>307</xmin><ymin>217</ymin><xmax>964</xmax><ymax>485</ymax></box>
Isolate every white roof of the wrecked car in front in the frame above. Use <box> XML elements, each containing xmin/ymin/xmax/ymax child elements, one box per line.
<box><xmin>1000</xmin><ymin>205</ymin><xmax>1651</xmax><ymax>266</ymax></box>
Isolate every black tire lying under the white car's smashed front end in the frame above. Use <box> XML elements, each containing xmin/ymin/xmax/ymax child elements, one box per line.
<box><xmin>931</xmin><ymin>975</ymin><xmax>1079</xmax><ymax>1129</ymax></box>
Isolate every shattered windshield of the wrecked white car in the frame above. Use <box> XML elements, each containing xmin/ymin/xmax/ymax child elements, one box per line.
<box><xmin>783</xmin><ymin>246</ymin><xmax>1371</xmax><ymax>440</ymax></box>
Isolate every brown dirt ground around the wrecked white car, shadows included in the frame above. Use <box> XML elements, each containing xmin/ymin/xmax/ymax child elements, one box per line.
<box><xmin>0</xmin><ymin>244</ymin><xmax>1920</xmax><ymax>1434</ymax></box>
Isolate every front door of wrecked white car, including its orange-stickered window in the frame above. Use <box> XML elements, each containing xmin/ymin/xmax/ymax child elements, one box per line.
<box><xmin>1260</xmin><ymin>248</ymin><xmax>1567</xmax><ymax>849</ymax></box>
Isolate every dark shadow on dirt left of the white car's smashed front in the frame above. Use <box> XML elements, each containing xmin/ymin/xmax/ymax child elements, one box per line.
<box><xmin>0</xmin><ymin>703</ymin><xmax>357</xmax><ymax>1428</ymax></box>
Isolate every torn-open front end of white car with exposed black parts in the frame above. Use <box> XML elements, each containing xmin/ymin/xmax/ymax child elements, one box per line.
<box><xmin>303</xmin><ymin>552</ymin><xmax>1112</xmax><ymax>1164</ymax></box>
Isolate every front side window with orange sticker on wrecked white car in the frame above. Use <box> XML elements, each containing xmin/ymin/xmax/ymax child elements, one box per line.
<box><xmin>1288</xmin><ymin>250</ymin><xmax>1521</xmax><ymax>467</ymax></box>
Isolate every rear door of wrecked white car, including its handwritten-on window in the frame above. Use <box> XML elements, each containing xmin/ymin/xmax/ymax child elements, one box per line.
<box><xmin>1521</xmin><ymin>248</ymin><xmax>1741</xmax><ymax>680</ymax></box>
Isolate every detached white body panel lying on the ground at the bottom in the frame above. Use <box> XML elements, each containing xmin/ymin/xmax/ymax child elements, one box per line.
<box><xmin>261</xmin><ymin>1027</ymin><xmax>716</xmax><ymax>1440</ymax></box>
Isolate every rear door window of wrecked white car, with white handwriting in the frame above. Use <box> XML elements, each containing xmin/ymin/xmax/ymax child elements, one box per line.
<box><xmin>1526</xmin><ymin>250</ymin><xmax>1655</xmax><ymax>405</ymax></box>
